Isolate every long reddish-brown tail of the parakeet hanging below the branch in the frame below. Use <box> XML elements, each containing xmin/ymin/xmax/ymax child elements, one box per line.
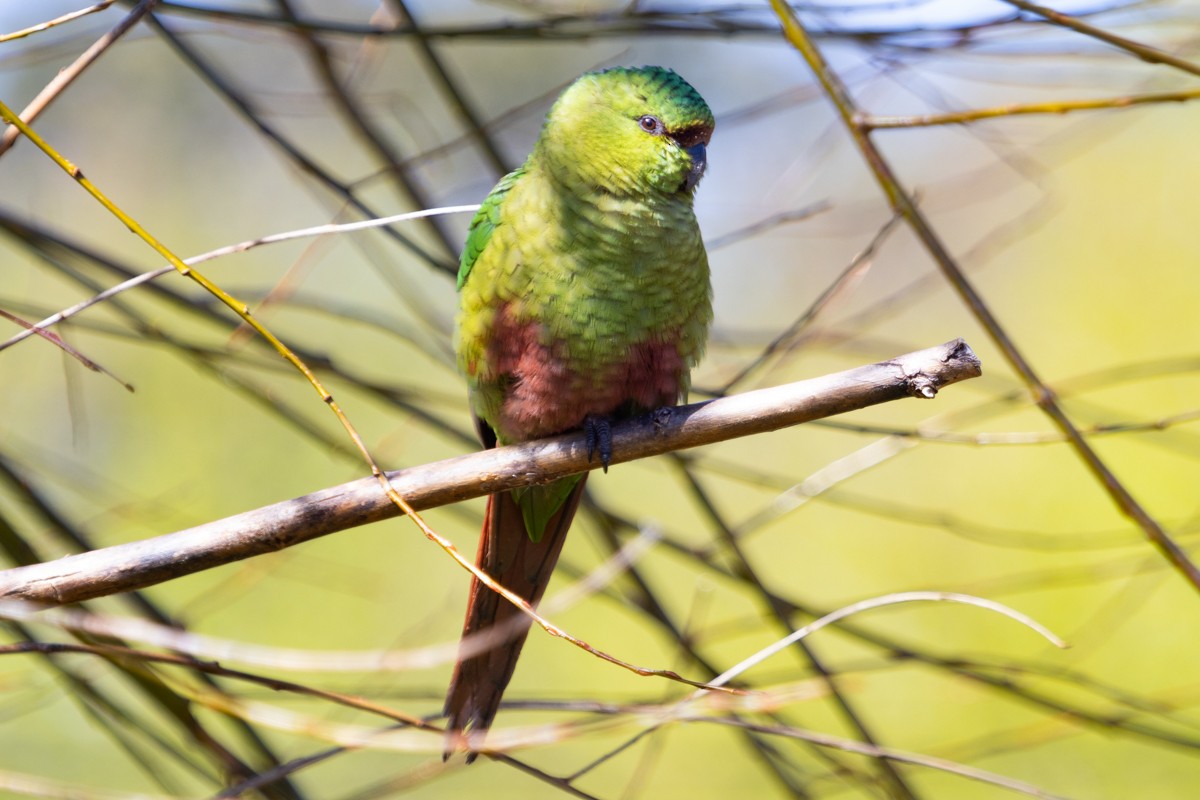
<box><xmin>444</xmin><ymin>475</ymin><xmax>587</xmax><ymax>764</ymax></box>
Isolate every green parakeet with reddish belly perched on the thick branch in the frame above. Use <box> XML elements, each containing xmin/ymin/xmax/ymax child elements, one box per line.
<box><xmin>445</xmin><ymin>67</ymin><xmax>714</xmax><ymax>762</ymax></box>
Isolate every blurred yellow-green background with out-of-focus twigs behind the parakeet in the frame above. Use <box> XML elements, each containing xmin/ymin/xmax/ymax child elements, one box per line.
<box><xmin>0</xmin><ymin>0</ymin><xmax>1200</xmax><ymax>800</ymax></box>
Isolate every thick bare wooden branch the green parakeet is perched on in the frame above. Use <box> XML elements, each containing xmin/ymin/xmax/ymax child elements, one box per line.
<box><xmin>0</xmin><ymin>339</ymin><xmax>980</xmax><ymax>604</ymax></box>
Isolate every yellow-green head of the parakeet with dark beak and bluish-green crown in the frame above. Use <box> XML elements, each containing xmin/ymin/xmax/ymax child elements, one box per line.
<box><xmin>536</xmin><ymin>67</ymin><xmax>714</xmax><ymax>197</ymax></box>
